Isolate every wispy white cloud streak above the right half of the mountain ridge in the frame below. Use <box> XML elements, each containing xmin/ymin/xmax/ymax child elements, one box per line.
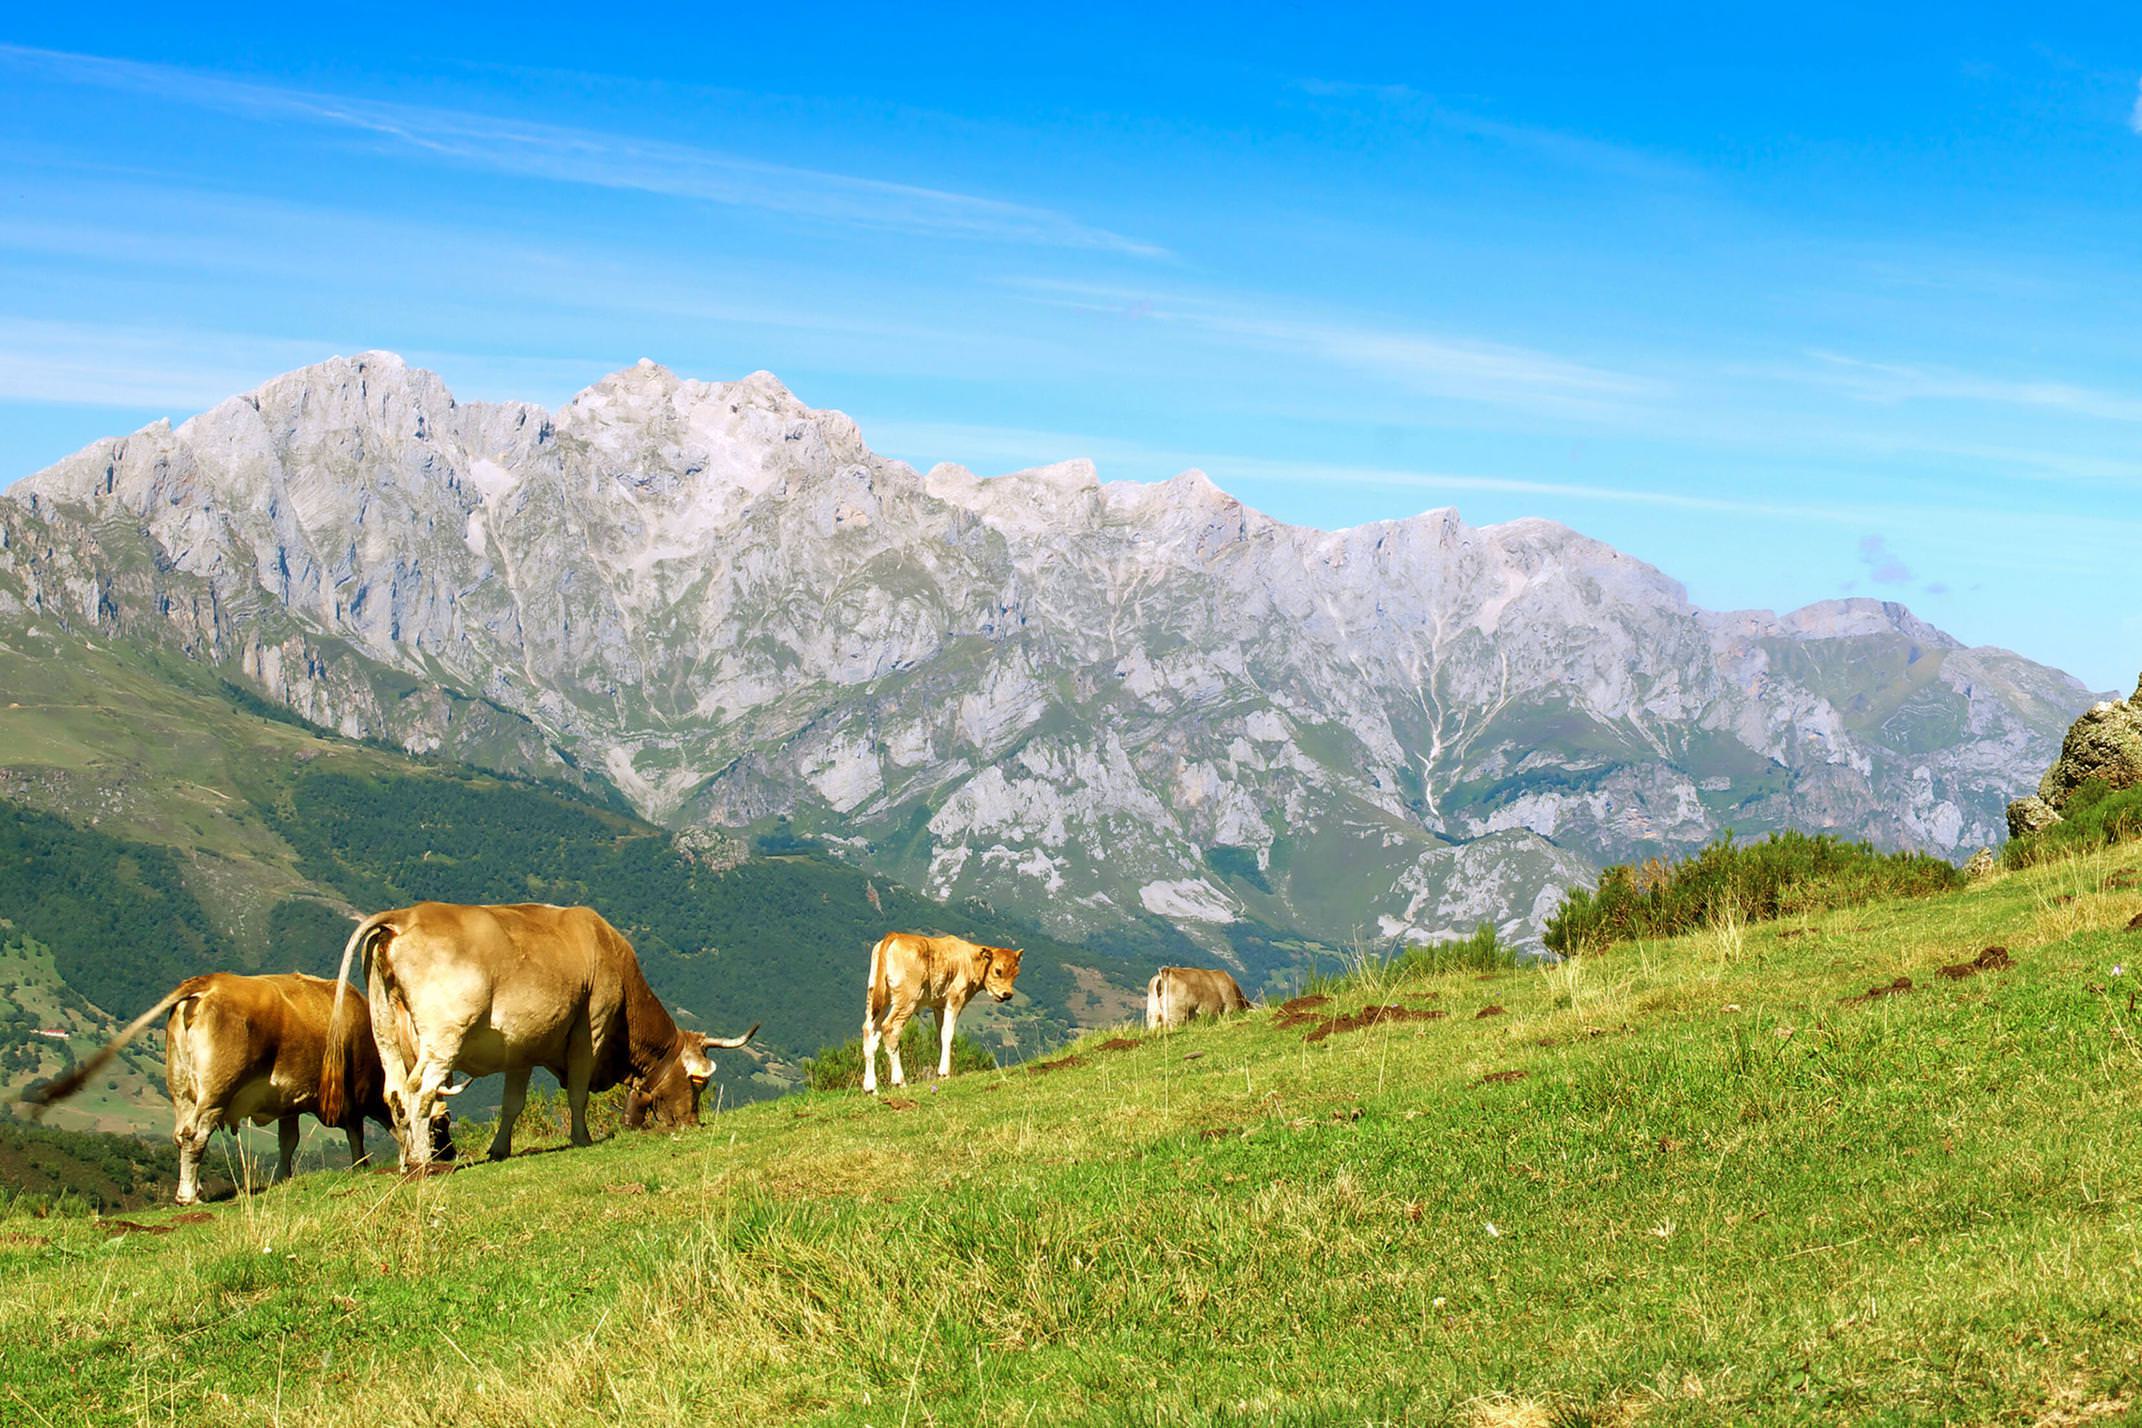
<box><xmin>1013</xmin><ymin>280</ymin><xmax>1664</xmax><ymax>415</ymax></box>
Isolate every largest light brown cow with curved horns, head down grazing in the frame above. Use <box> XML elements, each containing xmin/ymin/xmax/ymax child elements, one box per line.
<box><xmin>321</xmin><ymin>903</ymin><xmax>758</xmax><ymax>1169</ymax></box>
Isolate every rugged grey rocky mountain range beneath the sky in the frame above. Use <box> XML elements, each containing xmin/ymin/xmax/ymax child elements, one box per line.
<box><xmin>0</xmin><ymin>353</ymin><xmax>2091</xmax><ymax>953</ymax></box>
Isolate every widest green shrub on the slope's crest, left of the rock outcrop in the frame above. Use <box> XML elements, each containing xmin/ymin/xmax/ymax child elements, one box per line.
<box><xmin>1547</xmin><ymin>831</ymin><xmax>1964</xmax><ymax>957</ymax></box>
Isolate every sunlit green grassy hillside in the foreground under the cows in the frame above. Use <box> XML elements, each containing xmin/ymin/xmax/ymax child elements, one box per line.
<box><xmin>0</xmin><ymin>846</ymin><xmax>2142</xmax><ymax>1424</ymax></box>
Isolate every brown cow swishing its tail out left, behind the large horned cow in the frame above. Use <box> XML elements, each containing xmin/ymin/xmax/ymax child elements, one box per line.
<box><xmin>28</xmin><ymin>972</ymin><xmax>450</xmax><ymax>1205</ymax></box>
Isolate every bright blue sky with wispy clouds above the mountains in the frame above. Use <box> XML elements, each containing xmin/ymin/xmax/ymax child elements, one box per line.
<box><xmin>0</xmin><ymin>4</ymin><xmax>2142</xmax><ymax>692</ymax></box>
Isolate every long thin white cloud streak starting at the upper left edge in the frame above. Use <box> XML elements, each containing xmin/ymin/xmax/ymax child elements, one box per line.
<box><xmin>0</xmin><ymin>45</ymin><xmax>1165</xmax><ymax>257</ymax></box>
